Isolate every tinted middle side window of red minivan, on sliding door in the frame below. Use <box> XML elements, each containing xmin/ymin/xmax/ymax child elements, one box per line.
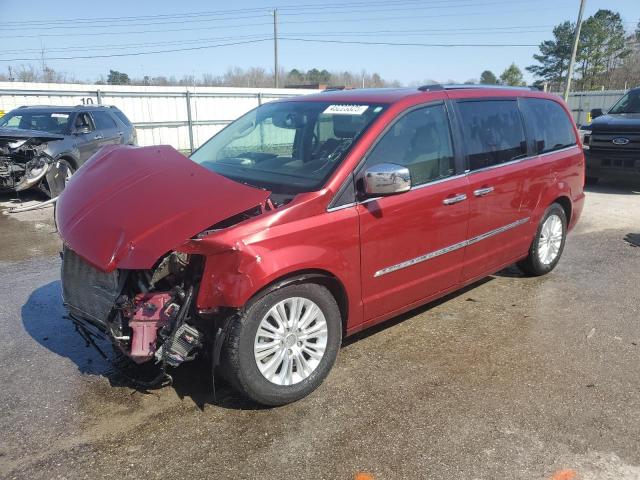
<box><xmin>458</xmin><ymin>100</ymin><xmax>527</xmax><ymax>171</ymax></box>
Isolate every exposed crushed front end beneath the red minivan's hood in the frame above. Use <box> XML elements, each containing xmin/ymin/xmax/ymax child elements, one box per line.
<box><xmin>62</xmin><ymin>247</ymin><xmax>206</xmax><ymax>371</ymax></box>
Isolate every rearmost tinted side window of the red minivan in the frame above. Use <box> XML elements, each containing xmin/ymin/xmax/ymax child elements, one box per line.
<box><xmin>523</xmin><ymin>98</ymin><xmax>576</xmax><ymax>153</ymax></box>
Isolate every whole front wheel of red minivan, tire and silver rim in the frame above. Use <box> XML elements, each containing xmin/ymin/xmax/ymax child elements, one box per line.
<box><xmin>222</xmin><ymin>283</ymin><xmax>342</xmax><ymax>405</ymax></box>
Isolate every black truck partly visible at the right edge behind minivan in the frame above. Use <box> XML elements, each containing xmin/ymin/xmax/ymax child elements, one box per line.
<box><xmin>582</xmin><ymin>87</ymin><xmax>640</xmax><ymax>184</ymax></box>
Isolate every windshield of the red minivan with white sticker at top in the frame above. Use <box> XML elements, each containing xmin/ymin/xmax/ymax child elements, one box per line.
<box><xmin>191</xmin><ymin>101</ymin><xmax>385</xmax><ymax>194</ymax></box>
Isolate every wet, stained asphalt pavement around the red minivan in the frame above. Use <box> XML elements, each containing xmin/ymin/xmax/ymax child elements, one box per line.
<box><xmin>0</xmin><ymin>184</ymin><xmax>640</xmax><ymax>480</ymax></box>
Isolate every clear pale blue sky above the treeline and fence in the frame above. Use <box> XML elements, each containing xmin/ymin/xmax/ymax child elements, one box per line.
<box><xmin>0</xmin><ymin>0</ymin><xmax>640</xmax><ymax>85</ymax></box>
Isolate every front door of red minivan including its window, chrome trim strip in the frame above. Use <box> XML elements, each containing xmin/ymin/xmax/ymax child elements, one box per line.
<box><xmin>357</xmin><ymin>103</ymin><xmax>469</xmax><ymax>323</ymax></box>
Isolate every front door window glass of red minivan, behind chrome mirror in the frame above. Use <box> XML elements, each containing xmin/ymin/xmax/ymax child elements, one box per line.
<box><xmin>365</xmin><ymin>105</ymin><xmax>455</xmax><ymax>185</ymax></box>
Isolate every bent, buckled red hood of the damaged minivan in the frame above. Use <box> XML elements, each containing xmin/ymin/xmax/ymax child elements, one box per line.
<box><xmin>56</xmin><ymin>146</ymin><xmax>269</xmax><ymax>271</ymax></box>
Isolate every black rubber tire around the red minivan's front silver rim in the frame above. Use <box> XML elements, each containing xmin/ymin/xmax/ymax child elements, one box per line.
<box><xmin>221</xmin><ymin>283</ymin><xmax>342</xmax><ymax>406</ymax></box>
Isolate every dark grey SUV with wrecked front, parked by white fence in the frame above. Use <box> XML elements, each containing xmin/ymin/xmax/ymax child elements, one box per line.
<box><xmin>0</xmin><ymin>105</ymin><xmax>136</xmax><ymax>197</ymax></box>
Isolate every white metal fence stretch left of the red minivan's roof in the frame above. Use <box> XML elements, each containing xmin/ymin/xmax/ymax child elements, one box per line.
<box><xmin>0</xmin><ymin>82</ymin><xmax>317</xmax><ymax>150</ymax></box>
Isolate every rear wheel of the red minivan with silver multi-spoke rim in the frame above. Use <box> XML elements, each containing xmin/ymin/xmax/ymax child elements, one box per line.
<box><xmin>518</xmin><ymin>203</ymin><xmax>567</xmax><ymax>276</ymax></box>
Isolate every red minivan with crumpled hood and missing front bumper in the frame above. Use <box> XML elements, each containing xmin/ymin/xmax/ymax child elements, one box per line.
<box><xmin>56</xmin><ymin>85</ymin><xmax>585</xmax><ymax>405</ymax></box>
